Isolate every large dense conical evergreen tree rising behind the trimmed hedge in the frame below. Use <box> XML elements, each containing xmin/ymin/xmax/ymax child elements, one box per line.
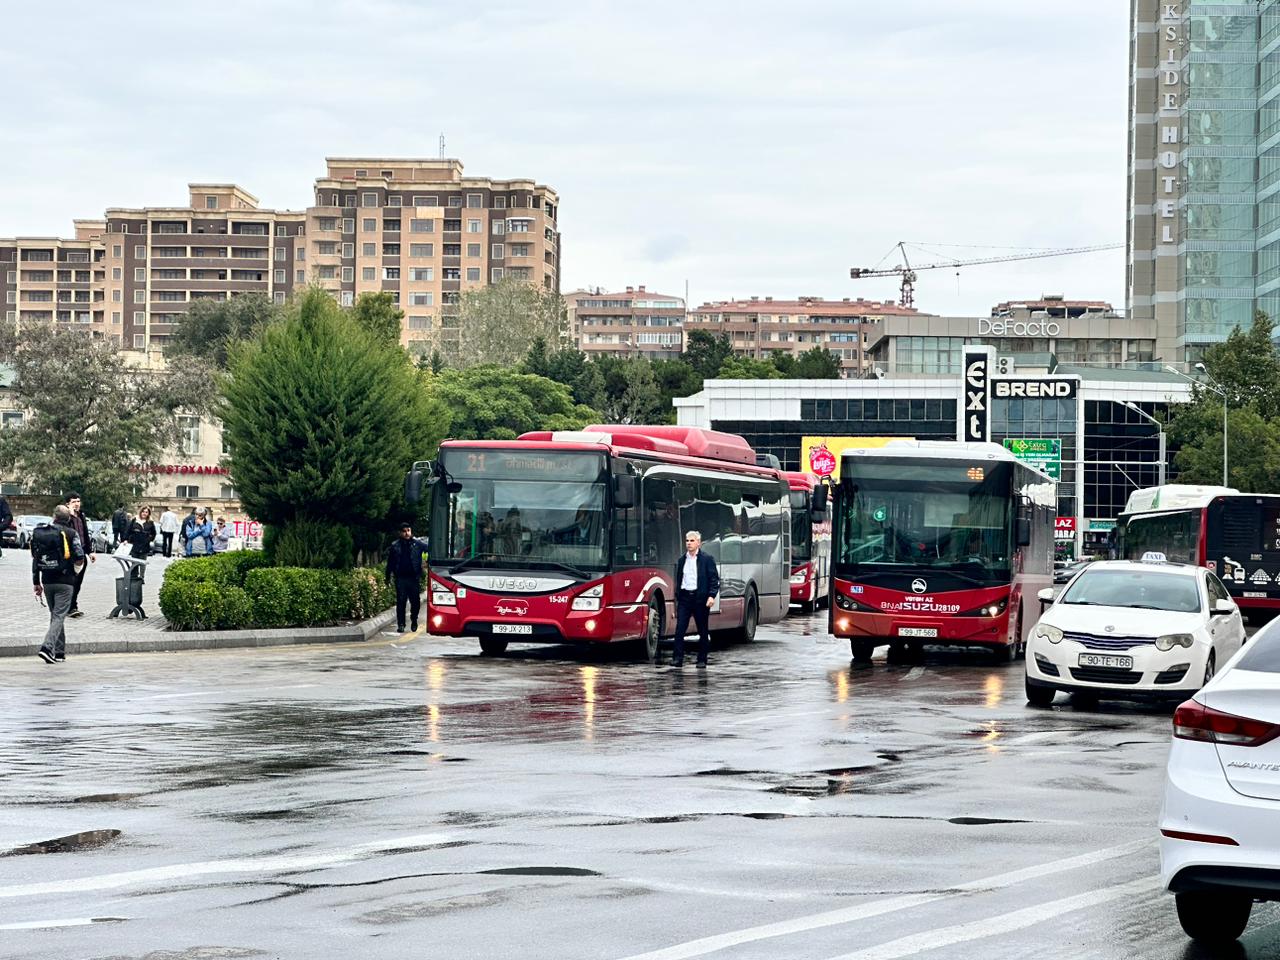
<box><xmin>219</xmin><ymin>289</ymin><xmax>449</xmax><ymax>568</ymax></box>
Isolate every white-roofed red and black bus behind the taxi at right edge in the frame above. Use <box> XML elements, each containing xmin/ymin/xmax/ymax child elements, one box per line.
<box><xmin>1116</xmin><ymin>484</ymin><xmax>1280</xmax><ymax>614</ymax></box>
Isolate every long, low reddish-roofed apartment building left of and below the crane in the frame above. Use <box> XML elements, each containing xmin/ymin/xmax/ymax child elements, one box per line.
<box><xmin>685</xmin><ymin>297</ymin><xmax>920</xmax><ymax>376</ymax></box>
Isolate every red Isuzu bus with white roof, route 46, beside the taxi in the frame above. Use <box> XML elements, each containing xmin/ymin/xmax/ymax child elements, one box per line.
<box><xmin>829</xmin><ymin>440</ymin><xmax>1056</xmax><ymax>660</ymax></box>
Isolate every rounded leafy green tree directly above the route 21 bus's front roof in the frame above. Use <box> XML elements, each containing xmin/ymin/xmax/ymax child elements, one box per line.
<box><xmin>431</xmin><ymin>366</ymin><xmax>599</xmax><ymax>440</ymax></box>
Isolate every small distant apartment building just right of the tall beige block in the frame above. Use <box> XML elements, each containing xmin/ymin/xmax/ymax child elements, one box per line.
<box><xmin>564</xmin><ymin>285</ymin><xmax>685</xmax><ymax>360</ymax></box>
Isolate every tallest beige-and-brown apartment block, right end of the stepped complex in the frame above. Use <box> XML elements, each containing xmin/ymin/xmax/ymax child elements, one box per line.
<box><xmin>306</xmin><ymin>157</ymin><xmax>561</xmax><ymax>353</ymax></box>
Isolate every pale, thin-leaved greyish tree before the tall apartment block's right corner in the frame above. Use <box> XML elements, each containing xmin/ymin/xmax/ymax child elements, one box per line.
<box><xmin>447</xmin><ymin>279</ymin><xmax>568</xmax><ymax>367</ymax></box>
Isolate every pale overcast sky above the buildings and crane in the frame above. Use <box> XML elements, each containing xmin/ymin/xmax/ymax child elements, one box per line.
<box><xmin>0</xmin><ymin>0</ymin><xmax>1129</xmax><ymax>315</ymax></box>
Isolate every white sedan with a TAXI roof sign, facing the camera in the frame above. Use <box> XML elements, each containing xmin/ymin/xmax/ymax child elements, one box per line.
<box><xmin>1027</xmin><ymin>561</ymin><xmax>1244</xmax><ymax>707</ymax></box>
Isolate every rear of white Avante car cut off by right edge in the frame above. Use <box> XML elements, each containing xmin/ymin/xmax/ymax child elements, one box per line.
<box><xmin>1160</xmin><ymin>620</ymin><xmax>1280</xmax><ymax>955</ymax></box>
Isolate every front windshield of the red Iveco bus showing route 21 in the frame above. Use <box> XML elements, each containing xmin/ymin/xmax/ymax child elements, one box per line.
<box><xmin>431</xmin><ymin>449</ymin><xmax>608</xmax><ymax>571</ymax></box>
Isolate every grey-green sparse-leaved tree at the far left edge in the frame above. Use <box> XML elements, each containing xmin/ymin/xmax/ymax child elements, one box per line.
<box><xmin>0</xmin><ymin>324</ymin><xmax>214</xmax><ymax>517</ymax></box>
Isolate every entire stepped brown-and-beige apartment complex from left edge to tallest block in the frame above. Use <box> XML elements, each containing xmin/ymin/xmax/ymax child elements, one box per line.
<box><xmin>0</xmin><ymin>157</ymin><xmax>561</xmax><ymax>352</ymax></box>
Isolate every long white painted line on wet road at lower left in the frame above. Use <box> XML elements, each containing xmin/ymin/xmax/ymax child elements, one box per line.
<box><xmin>0</xmin><ymin>833</ymin><xmax>454</xmax><ymax>899</ymax></box>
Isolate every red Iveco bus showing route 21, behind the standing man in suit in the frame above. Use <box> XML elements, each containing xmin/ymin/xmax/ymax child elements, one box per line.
<box><xmin>406</xmin><ymin>425</ymin><xmax>791</xmax><ymax>662</ymax></box>
